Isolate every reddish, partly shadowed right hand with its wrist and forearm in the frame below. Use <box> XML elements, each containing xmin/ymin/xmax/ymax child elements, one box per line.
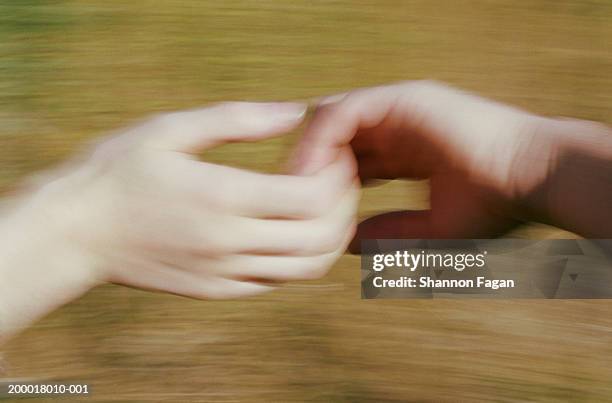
<box><xmin>293</xmin><ymin>81</ymin><xmax>612</xmax><ymax>252</ymax></box>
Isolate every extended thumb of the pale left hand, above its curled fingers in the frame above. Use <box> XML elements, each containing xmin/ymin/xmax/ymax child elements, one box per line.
<box><xmin>135</xmin><ymin>102</ymin><xmax>306</xmax><ymax>152</ymax></box>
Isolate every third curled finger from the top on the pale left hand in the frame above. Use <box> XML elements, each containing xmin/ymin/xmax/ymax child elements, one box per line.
<box><xmin>217</xmin><ymin>226</ymin><xmax>354</xmax><ymax>282</ymax></box>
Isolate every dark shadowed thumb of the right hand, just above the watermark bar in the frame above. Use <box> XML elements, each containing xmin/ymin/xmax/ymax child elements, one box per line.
<box><xmin>349</xmin><ymin>210</ymin><xmax>441</xmax><ymax>254</ymax></box>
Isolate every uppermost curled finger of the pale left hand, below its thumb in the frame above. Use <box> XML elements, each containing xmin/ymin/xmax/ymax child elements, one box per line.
<box><xmin>166</xmin><ymin>147</ymin><xmax>357</xmax><ymax>219</ymax></box>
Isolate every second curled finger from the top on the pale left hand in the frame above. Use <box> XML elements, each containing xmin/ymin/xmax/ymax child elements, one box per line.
<box><xmin>226</xmin><ymin>184</ymin><xmax>359</xmax><ymax>255</ymax></box>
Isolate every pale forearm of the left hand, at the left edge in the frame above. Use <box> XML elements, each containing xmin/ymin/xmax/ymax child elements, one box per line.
<box><xmin>0</xmin><ymin>181</ymin><xmax>95</xmax><ymax>342</ymax></box>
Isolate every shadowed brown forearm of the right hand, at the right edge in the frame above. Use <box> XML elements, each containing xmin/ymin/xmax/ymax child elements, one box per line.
<box><xmin>532</xmin><ymin>120</ymin><xmax>612</xmax><ymax>238</ymax></box>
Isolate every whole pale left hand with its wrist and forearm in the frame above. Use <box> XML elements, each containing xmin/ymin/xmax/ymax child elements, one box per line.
<box><xmin>0</xmin><ymin>103</ymin><xmax>359</xmax><ymax>337</ymax></box>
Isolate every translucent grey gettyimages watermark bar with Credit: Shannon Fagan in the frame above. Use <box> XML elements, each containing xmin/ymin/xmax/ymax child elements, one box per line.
<box><xmin>361</xmin><ymin>239</ymin><xmax>612</xmax><ymax>299</ymax></box>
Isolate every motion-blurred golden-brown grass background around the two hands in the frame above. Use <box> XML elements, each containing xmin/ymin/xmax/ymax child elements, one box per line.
<box><xmin>0</xmin><ymin>0</ymin><xmax>612</xmax><ymax>402</ymax></box>
